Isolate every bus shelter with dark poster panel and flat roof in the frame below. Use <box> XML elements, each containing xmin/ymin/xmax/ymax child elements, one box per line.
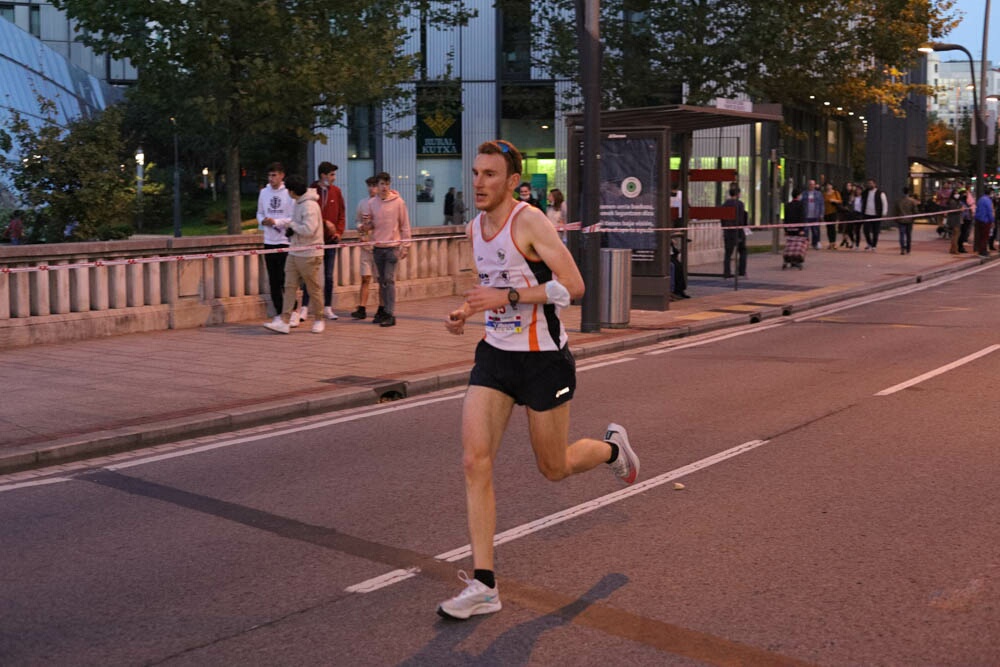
<box><xmin>567</xmin><ymin>105</ymin><xmax>782</xmax><ymax>310</ymax></box>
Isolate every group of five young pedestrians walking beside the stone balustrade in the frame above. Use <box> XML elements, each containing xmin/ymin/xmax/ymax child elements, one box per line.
<box><xmin>257</xmin><ymin>162</ymin><xmax>411</xmax><ymax>334</ymax></box>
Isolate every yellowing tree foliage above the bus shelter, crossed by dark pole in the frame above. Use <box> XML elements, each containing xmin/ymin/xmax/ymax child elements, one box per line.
<box><xmin>528</xmin><ymin>0</ymin><xmax>955</xmax><ymax>110</ymax></box>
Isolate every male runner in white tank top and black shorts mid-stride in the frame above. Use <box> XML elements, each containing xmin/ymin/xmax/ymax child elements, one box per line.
<box><xmin>438</xmin><ymin>141</ymin><xmax>639</xmax><ymax>619</ymax></box>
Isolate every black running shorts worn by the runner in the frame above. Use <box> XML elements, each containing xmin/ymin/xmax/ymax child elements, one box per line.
<box><xmin>469</xmin><ymin>340</ymin><xmax>576</xmax><ymax>412</ymax></box>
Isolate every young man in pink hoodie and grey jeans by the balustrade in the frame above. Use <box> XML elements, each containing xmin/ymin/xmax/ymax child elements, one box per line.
<box><xmin>368</xmin><ymin>171</ymin><xmax>410</xmax><ymax>327</ymax></box>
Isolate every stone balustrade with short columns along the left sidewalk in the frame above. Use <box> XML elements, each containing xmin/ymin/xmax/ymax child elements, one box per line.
<box><xmin>0</xmin><ymin>227</ymin><xmax>476</xmax><ymax>349</ymax></box>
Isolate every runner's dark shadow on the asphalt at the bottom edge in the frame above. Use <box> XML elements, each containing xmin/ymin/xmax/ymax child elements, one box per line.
<box><xmin>399</xmin><ymin>573</ymin><xmax>628</xmax><ymax>667</ymax></box>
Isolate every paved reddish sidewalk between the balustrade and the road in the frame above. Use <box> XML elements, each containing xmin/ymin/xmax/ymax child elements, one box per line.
<box><xmin>0</xmin><ymin>225</ymin><xmax>983</xmax><ymax>473</ymax></box>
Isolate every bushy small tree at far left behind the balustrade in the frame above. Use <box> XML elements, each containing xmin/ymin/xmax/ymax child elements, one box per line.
<box><xmin>0</xmin><ymin>99</ymin><xmax>155</xmax><ymax>242</ymax></box>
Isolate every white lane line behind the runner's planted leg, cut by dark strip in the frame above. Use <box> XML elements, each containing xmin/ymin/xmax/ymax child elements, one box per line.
<box><xmin>344</xmin><ymin>440</ymin><xmax>769</xmax><ymax>593</ymax></box>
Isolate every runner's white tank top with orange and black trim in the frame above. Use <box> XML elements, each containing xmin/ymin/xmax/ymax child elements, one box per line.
<box><xmin>470</xmin><ymin>202</ymin><xmax>568</xmax><ymax>352</ymax></box>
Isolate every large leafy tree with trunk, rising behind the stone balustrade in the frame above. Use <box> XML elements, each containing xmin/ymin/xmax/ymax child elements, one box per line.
<box><xmin>53</xmin><ymin>0</ymin><xmax>469</xmax><ymax>233</ymax></box>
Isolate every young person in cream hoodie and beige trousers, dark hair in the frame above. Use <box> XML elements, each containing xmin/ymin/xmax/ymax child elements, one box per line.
<box><xmin>263</xmin><ymin>176</ymin><xmax>326</xmax><ymax>334</ymax></box>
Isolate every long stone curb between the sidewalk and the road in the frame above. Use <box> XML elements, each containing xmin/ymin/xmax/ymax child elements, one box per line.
<box><xmin>0</xmin><ymin>257</ymin><xmax>995</xmax><ymax>474</ymax></box>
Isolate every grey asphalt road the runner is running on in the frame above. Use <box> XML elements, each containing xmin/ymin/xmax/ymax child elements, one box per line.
<box><xmin>0</xmin><ymin>272</ymin><xmax>1000</xmax><ymax>666</ymax></box>
